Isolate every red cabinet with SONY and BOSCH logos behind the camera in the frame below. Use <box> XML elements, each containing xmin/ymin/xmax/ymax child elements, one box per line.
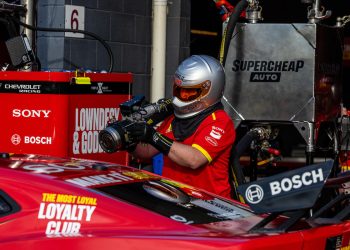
<box><xmin>0</xmin><ymin>71</ymin><xmax>132</xmax><ymax>164</ymax></box>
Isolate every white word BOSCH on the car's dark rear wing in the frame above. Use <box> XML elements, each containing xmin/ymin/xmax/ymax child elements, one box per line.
<box><xmin>270</xmin><ymin>168</ymin><xmax>325</xmax><ymax>195</ymax></box>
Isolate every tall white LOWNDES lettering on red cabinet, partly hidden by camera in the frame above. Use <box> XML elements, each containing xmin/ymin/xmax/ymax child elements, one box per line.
<box><xmin>72</xmin><ymin>108</ymin><xmax>120</xmax><ymax>154</ymax></box>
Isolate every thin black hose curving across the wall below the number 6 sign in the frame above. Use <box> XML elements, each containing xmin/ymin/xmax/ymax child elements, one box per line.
<box><xmin>11</xmin><ymin>16</ymin><xmax>114</xmax><ymax>73</ymax></box>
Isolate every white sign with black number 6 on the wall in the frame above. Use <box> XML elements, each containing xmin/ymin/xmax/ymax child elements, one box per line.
<box><xmin>64</xmin><ymin>5</ymin><xmax>85</xmax><ymax>38</ymax></box>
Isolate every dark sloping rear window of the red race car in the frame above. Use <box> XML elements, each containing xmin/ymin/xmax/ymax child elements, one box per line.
<box><xmin>95</xmin><ymin>180</ymin><xmax>253</xmax><ymax>224</ymax></box>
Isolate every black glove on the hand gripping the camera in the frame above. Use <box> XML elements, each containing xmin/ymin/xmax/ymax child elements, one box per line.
<box><xmin>126</xmin><ymin>122</ymin><xmax>174</xmax><ymax>155</ymax></box>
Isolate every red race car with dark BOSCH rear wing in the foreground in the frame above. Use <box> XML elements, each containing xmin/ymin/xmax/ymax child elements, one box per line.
<box><xmin>0</xmin><ymin>154</ymin><xmax>350</xmax><ymax>250</ymax></box>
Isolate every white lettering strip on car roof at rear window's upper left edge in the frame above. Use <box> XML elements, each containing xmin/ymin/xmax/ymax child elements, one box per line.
<box><xmin>66</xmin><ymin>171</ymin><xmax>134</xmax><ymax>187</ymax></box>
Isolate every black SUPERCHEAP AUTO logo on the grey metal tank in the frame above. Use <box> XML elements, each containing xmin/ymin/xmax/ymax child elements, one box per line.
<box><xmin>232</xmin><ymin>59</ymin><xmax>304</xmax><ymax>82</ymax></box>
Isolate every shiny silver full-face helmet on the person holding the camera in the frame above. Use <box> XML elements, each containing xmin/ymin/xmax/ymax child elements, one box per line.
<box><xmin>173</xmin><ymin>55</ymin><xmax>225</xmax><ymax>118</ymax></box>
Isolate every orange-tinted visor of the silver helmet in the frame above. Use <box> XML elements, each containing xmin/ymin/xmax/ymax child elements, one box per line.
<box><xmin>173</xmin><ymin>81</ymin><xmax>210</xmax><ymax>102</ymax></box>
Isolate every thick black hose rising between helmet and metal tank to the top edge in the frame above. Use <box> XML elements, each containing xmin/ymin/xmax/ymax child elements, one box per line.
<box><xmin>220</xmin><ymin>0</ymin><xmax>249</xmax><ymax>65</ymax></box>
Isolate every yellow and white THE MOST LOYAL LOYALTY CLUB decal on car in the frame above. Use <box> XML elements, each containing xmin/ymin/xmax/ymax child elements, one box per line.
<box><xmin>38</xmin><ymin>193</ymin><xmax>97</xmax><ymax>236</ymax></box>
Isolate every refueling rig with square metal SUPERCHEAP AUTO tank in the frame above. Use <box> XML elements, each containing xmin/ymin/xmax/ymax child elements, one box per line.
<box><xmin>216</xmin><ymin>0</ymin><xmax>349</xmax><ymax>195</ymax></box>
